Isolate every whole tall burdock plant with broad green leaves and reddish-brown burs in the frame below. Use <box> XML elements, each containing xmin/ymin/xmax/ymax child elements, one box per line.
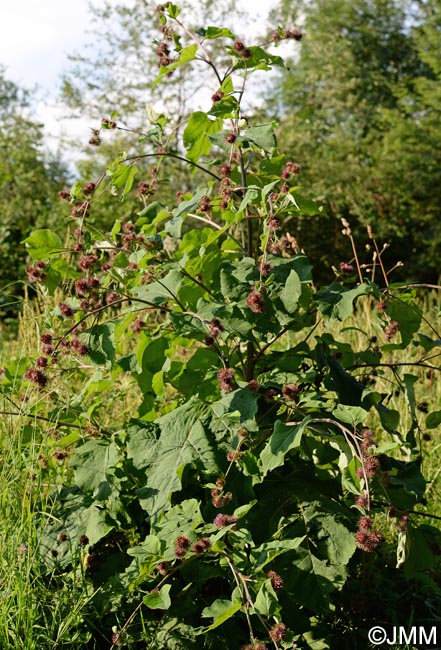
<box><xmin>1</xmin><ymin>3</ymin><xmax>441</xmax><ymax>650</ymax></box>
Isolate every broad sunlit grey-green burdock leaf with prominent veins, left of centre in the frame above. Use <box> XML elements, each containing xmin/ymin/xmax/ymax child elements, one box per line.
<box><xmin>139</xmin><ymin>399</ymin><xmax>217</xmax><ymax>520</ymax></box>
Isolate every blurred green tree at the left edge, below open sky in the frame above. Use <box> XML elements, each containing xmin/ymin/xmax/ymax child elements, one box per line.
<box><xmin>0</xmin><ymin>68</ymin><xmax>66</xmax><ymax>318</ymax></box>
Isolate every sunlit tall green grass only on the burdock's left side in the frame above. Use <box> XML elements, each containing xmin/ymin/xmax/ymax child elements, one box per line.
<box><xmin>0</xmin><ymin>296</ymin><xmax>97</xmax><ymax>650</ymax></box>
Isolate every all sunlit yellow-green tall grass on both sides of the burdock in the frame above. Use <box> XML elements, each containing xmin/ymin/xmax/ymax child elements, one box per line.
<box><xmin>0</xmin><ymin>294</ymin><xmax>441</xmax><ymax>650</ymax></box>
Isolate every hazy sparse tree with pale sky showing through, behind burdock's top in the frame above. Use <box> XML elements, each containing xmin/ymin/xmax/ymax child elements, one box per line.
<box><xmin>55</xmin><ymin>0</ymin><xmax>246</xmax><ymax>234</ymax></box>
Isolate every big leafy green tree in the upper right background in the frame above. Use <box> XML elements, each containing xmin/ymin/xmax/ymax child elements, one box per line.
<box><xmin>273</xmin><ymin>0</ymin><xmax>439</xmax><ymax>280</ymax></box>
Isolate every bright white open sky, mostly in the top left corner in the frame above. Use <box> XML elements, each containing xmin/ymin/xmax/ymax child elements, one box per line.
<box><xmin>0</xmin><ymin>0</ymin><xmax>275</xmax><ymax>159</ymax></box>
